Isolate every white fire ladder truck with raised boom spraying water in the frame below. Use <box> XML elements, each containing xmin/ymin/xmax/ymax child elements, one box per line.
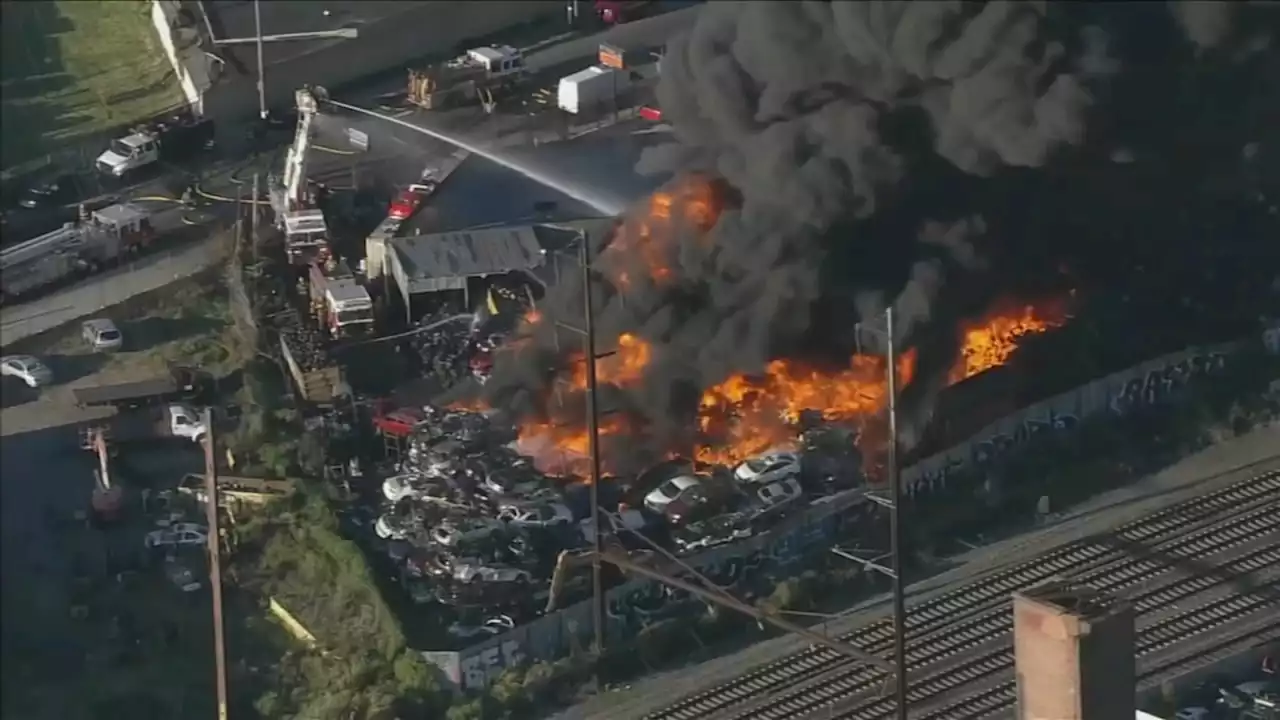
<box><xmin>271</xmin><ymin>86</ymin><xmax>330</xmax><ymax>266</ymax></box>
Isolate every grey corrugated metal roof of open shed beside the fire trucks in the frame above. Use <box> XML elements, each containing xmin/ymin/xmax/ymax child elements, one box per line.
<box><xmin>390</xmin><ymin>225</ymin><xmax>545</xmax><ymax>293</ymax></box>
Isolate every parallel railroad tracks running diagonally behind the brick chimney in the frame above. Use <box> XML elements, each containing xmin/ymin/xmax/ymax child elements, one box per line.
<box><xmin>646</xmin><ymin>471</ymin><xmax>1280</xmax><ymax>720</ymax></box>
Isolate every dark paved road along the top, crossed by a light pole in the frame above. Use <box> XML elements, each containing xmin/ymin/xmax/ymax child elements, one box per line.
<box><xmin>204</xmin><ymin>0</ymin><xmax>564</xmax><ymax>119</ymax></box>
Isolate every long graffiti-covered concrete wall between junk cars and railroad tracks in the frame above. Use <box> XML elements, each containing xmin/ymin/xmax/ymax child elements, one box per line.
<box><xmin>424</xmin><ymin>343</ymin><xmax>1236</xmax><ymax>691</ymax></box>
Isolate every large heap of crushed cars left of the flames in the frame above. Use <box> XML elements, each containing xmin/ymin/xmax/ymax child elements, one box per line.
<box><xmin>374</xmin><ymin>406</ymin><xmax>584</xmax><ymax>641</ymax></box>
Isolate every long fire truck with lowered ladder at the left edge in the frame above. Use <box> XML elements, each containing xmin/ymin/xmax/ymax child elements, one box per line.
<box><xmin>0</xmin><ymin>202</ymin><xmax>156</xmax><ymax>301</ymax></box>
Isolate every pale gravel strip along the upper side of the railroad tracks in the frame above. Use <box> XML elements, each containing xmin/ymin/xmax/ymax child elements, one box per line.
<box><xmin>554</xmin><ymin>425</ymin><xmax>1280</xmax><ymax>720</ymax></box>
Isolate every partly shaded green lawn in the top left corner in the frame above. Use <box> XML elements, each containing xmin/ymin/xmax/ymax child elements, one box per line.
<box><xmin>0</xmin><ymin>0</ymin><xmax>183</xmax><ymax>170</ymax></box>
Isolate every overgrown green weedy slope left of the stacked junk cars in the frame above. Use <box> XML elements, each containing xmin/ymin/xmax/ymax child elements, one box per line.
<box><xmin>233</xmin><ymin>489</ymin><xmax>444</xmax><ymax>719</ymax></box>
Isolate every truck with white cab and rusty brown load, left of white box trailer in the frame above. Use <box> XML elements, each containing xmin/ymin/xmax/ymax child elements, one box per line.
<box><xmin>407</xmin><ymin>45</ymin><xmax>525</xmax><ymax>113</ymax></box>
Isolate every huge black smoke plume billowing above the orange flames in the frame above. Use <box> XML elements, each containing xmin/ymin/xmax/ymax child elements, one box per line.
<box><xmin>486</xmin><ymin>1</ymin><xmax>1280</xmax><ymax>458</ymax></box>
